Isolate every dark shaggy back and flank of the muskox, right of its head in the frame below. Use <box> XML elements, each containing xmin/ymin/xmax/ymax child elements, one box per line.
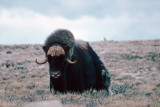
<box><xmin>59</xmin><ymin>41</ymin><xmax>110</xmax><ymax>92</ymax></box>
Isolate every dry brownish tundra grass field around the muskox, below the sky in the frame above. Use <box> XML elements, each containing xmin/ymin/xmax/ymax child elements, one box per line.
<box><xmin>0</xmin><ymin>40</ymin><xmax>160</xmax><ymax>107</ymax></box>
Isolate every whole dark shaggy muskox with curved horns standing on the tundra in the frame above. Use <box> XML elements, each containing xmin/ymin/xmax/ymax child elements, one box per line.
<box><xmin>36</xmin><ymin>29</ymin><xmax>110</xmax><ymax>94</ymax></box>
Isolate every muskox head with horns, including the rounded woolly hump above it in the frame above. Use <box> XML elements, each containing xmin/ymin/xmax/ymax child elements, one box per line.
<box><xmin>36</xmin><ymin>29</ymin><xmax>76</xmax><ymax>79</ymax></box>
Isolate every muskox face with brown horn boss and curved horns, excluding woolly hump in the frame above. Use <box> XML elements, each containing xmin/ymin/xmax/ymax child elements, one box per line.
<box><xmin>36</xmin><ymin>45</ymin><xmax>76</xmax><ymax>79</ymax></box>
